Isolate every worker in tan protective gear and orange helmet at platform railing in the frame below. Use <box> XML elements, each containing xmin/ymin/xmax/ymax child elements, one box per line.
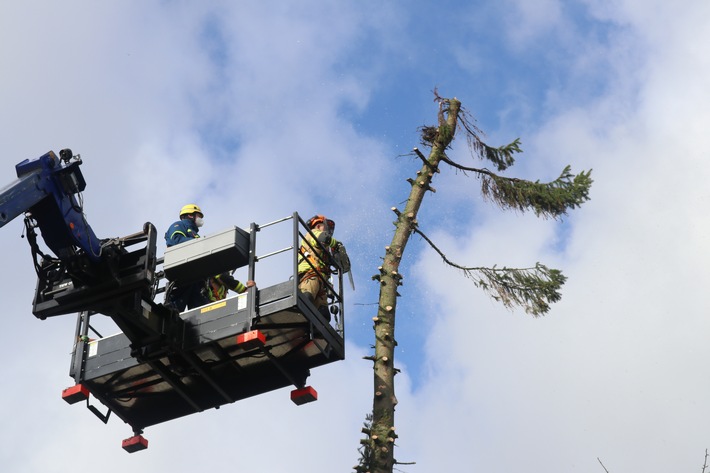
<box><xmin>298</xmin><ymin>215</ymin><xmax>343</xmax><ymax>322</ymax></box>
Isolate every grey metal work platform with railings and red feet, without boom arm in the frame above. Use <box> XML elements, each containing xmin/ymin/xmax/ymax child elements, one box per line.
<box><xmin>66</xmin><ymin>213</ymin><xmax>345</xmax><ymax>451</ymax></box>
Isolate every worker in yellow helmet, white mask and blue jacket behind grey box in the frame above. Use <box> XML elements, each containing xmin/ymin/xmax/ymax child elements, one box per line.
<box><xmin>165</xmin><ymin>204</ymin><xmax>210</xmax><ymax>312</ymax></box>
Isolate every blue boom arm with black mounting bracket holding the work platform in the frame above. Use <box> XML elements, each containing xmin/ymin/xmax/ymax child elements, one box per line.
<box><xmin>0</xmin><ymin>149</ymin><xmax>172</xmax><ymax>360</ymax></box>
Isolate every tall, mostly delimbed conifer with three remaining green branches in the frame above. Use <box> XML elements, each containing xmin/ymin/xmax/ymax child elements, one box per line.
<box><xmin>354</xmin><ymin>93</ymin><xmax>592</xmax><ymax>473</ymax></box>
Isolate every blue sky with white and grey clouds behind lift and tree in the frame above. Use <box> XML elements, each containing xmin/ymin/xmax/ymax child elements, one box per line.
<box><xmin>0</xmin><ymin>0</ymin><xmax>710</xmax><ymax>473</ymax></box>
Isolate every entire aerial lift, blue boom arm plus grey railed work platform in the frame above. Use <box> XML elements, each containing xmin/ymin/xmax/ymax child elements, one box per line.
<box><xmin>0</xmin><ymin>150</ymin><xmax>345</xmax><ymax>452</ymax></box>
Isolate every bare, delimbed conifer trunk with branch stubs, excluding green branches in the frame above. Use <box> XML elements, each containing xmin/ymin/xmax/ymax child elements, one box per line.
<box><xmin>369</xmin><ymin>99</ymin><xmax>461</xmax><ymax>473</ymax></box>
